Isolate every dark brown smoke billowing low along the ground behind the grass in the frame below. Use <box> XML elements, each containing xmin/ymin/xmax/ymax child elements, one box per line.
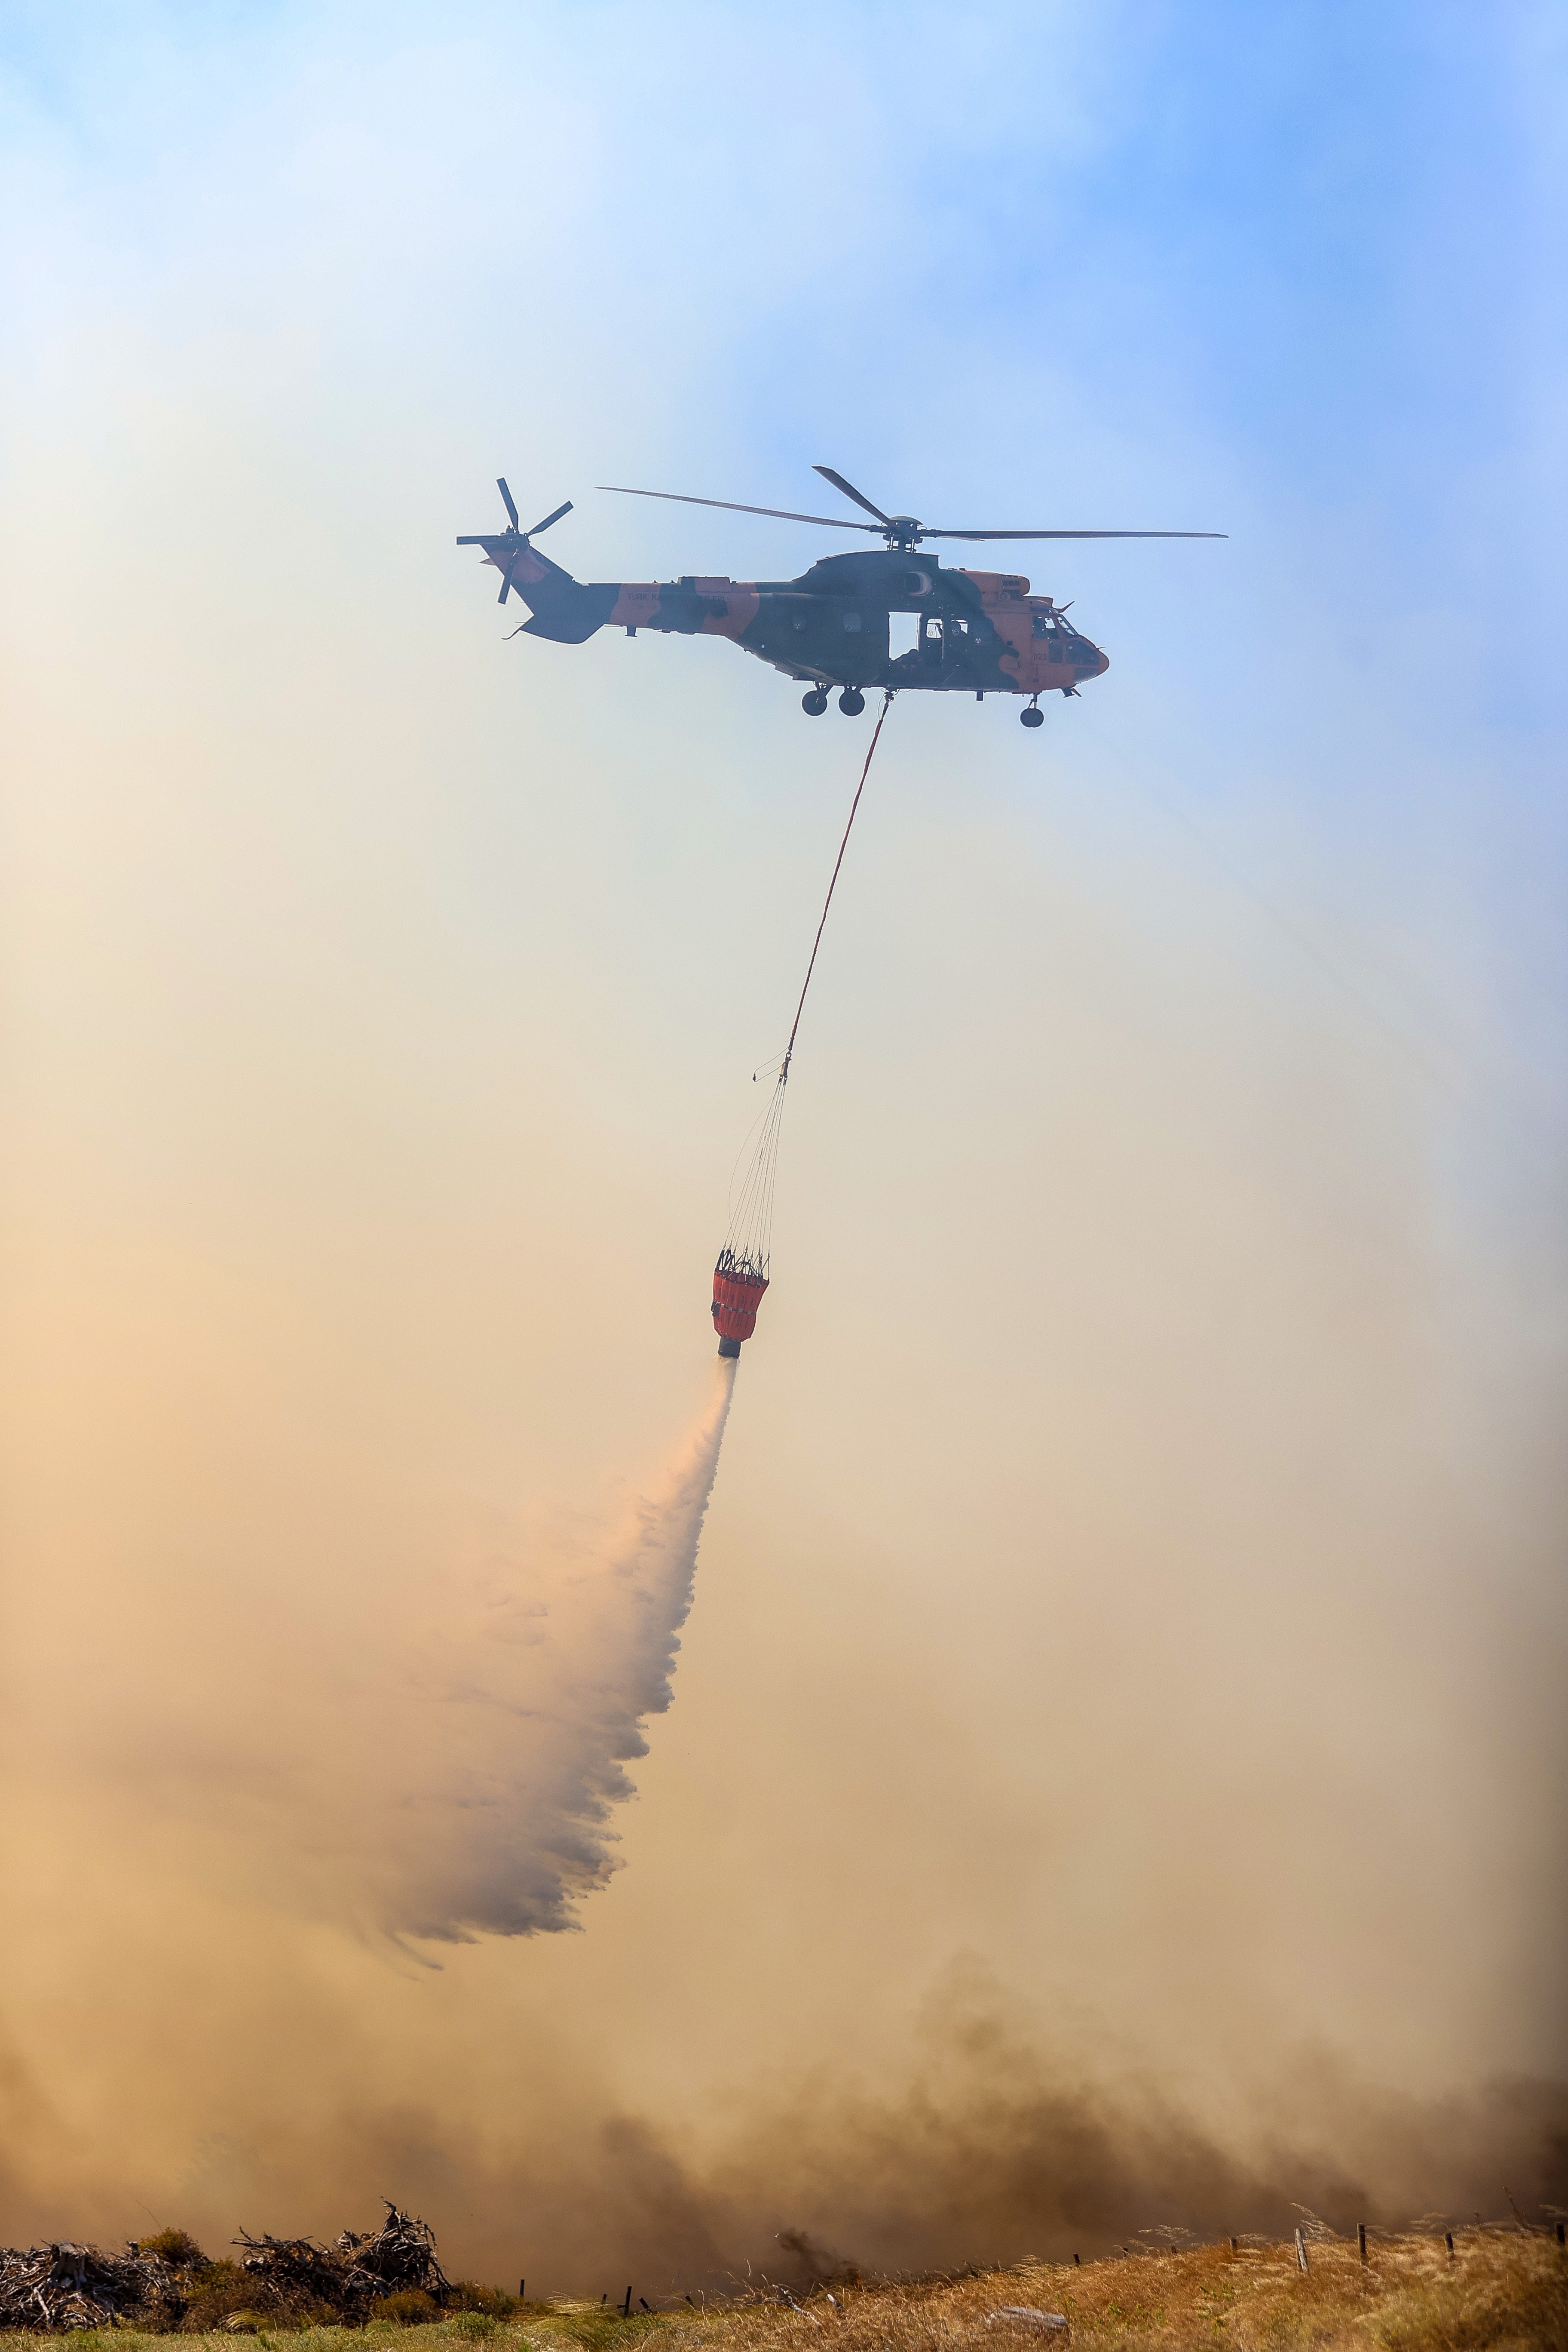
<box><xmin>61</xmin><ymin>2002</ymin><xmax>1568</xmax><ymax>2300</ymax></box>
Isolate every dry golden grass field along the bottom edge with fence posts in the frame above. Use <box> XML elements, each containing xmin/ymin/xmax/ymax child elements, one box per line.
<box><xmin>0</xmin><ymin>2230</ymin><xmax>1568</xmax><ymax>2352</ymax></box>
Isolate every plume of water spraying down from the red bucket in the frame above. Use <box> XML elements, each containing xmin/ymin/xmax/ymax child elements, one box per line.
<box><xmin>197</xmin><ymin>1364</ymin><xmax>733</xmax><ymax>1964</ymax></box>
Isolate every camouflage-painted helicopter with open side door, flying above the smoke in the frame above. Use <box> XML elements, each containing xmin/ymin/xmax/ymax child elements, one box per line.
<box><xmin>459</xmin><ymin>466</ymin><xmax>1229</xmax><ymax>727</ymax></box>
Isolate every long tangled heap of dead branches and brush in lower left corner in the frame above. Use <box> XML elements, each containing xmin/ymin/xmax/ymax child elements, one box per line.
<box><xmin>0</xmin><ymin>2202</ymin><xmax>451</xmax><ymax>2333</ymax></box>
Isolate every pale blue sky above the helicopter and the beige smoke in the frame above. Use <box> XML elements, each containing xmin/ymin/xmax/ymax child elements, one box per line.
<box><xmin>7</xmin><ymin>7</ymin><xmax>1563</xmax><ymax>926</ymax></box>
